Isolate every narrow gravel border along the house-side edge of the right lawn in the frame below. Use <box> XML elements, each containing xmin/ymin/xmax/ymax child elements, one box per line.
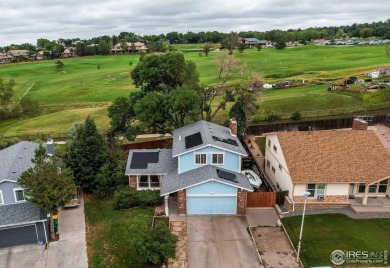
<box><xmin>282</xmin><ymin>208</ymin><xmax>390</xmax><ymax>219</ymax></box>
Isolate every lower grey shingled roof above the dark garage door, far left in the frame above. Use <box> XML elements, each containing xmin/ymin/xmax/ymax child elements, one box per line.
<box><xmin>0</xmin><ymin>202</ymin><xmax>46</xmax><ymax>227</ymax></box>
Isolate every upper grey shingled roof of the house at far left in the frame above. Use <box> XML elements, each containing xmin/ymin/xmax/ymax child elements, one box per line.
<box><xmin>0</xmin><ymin>141</ymin><xmax>39</xmax><ymax>182</ymax></box>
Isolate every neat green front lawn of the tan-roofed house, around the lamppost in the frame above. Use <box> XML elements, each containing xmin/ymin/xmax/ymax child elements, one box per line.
<box><xmin>282</xmin><ymin>214</ymin><xmax>390</xmax><ymax>267</ymax></box>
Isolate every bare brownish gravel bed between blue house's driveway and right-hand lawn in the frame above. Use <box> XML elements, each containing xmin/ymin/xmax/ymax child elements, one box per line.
<box><xmin>252</xmin><ymin>227</ymin><xmax>300</xmax><ymax>268</ymax></box>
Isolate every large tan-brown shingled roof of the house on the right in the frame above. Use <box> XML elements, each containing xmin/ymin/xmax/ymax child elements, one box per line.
<box><xmin>274</xmin><ymin>130</ymin><xmax>390</xmax><ymax>184</ymax></box>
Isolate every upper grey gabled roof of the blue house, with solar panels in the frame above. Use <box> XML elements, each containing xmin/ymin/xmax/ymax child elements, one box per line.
<box><xmin>172</xmin><ymin>120</ymin><xmax>247</xmax><ymax>157</ymax></box>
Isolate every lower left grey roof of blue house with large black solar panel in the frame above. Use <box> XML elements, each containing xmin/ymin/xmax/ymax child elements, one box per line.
<box><xmin>125</xmin><ymin>149</ymin><xmax>177</xmax><ymax>176</ymax></box>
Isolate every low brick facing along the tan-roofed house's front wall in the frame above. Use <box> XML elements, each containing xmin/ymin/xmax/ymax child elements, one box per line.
<box><xmin>283</xmin><ymin>195</ymin><xmax>350</xmax><ymax>212</ymax></box>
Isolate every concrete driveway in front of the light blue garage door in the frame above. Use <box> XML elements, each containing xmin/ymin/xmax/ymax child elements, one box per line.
<box><xmin>187</xmin><ymin>216</ymin><xmax>261</xmax><ymax>268</ymax></box>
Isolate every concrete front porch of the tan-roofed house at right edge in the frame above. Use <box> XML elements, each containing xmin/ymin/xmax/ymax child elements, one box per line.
<box><xmin>349</xmin><ymin>197</ymin><xmax>390</xmax><ymax>213</ymax></box>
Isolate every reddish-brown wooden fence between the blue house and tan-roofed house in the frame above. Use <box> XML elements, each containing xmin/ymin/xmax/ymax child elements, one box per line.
<box><xmin>247</xmin><ymin>191</ymin><xmax>288</xmax><ymax>208</ymax></box>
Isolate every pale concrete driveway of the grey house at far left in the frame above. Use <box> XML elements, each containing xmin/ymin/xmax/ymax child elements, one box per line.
<box><xmin>0</xmin><ymin>193</ymin><xmax>88</xmax><ymax>268</ymax></box>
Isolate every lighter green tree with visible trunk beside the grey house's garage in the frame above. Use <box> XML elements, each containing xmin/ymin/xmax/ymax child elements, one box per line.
<box><xmin>18</xmin><ymin>144</ymin><xmax>76</xmax><ymax>238</ymax></box>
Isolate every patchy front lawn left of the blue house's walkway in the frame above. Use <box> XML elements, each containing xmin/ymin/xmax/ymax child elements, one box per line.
<box><xmin>85</xmin><ymin>198</ymin><xmax>153</xmax><ymax>268</ymax></box>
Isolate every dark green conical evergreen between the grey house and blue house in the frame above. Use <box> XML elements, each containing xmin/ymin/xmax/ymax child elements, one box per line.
<box><xmin>64</xmin><ymin>116</ymin><xmax>108</xmax><ymax>192</ymax></box>
